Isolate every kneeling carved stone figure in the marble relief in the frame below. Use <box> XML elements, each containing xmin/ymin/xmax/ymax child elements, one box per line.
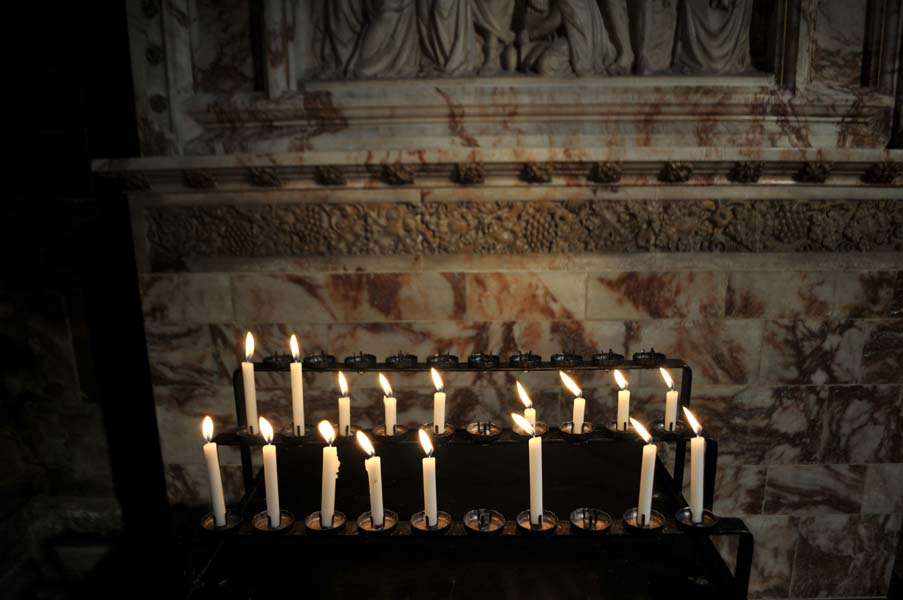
<box><xmin>518</xmin><ymin>0</ymin><xmax>615</xmax><ymax>77</ymax></box>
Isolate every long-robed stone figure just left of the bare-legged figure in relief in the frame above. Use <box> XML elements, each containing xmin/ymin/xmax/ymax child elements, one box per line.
<box><xmin>417</xmin><ymin>0</ymin><xmax>476</xmax><ymax>76</ymax></box>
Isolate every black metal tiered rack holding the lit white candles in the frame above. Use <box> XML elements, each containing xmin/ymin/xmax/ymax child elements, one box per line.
<box><xmin>192</xmin><ymin>350</ymin><xmax>753</xmax><ymax>598</ymax></box>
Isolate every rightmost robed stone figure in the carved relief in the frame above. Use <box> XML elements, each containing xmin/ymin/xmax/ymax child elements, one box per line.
<box><xmin>674</xmin><ymin>0</ymin><xmax>753</xmax><ymax>75</ymax></box>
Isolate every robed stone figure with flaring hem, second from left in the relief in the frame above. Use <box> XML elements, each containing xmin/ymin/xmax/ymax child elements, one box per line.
<box><xmin>354</xmin><ymin>0</ymin><xmax>420</xmax><ymax>78</ymax></box>
